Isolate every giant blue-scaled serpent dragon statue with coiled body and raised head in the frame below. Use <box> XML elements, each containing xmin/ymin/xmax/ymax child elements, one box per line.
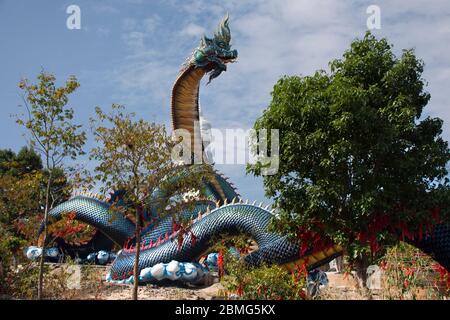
<box><xmin>37</xmin><ymin>17</ymin><xmax>450</xmax><ymax>281</ymax></box>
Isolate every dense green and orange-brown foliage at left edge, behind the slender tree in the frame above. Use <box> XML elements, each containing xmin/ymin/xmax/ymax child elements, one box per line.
<box><xmin>0</xmin><ymin>147</ymin><xmax>70</xmax><ymax>294</ymax></box>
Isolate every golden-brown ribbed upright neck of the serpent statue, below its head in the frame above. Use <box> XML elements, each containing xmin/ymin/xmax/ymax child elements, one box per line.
<box><xmin>171</xmin><ymin>65</ymin><xmax>208</xmax><ymax>159</ymax></box>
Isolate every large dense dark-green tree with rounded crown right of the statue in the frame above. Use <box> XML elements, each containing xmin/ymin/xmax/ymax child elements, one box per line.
<box><xmin>248</xmin><ymin>32</ymin><xmax>450</xmax><ymax>282</ymax></box>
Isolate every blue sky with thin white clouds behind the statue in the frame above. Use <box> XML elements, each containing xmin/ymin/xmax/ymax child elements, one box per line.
<box><xmin>0</xmin><ymin>0</ymin><xmax>450</xmax><ymax>203</ymax></box>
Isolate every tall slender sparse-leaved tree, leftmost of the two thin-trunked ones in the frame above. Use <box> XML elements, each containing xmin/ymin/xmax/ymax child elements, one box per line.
<box><xmin>17</xmin><ymin>71</ymin><xmax>86</xmax><ymax>299</ymax></box>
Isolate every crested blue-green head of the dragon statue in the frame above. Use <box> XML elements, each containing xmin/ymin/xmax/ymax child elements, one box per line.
<box><xmin>190</xmin><ymin>15</ymin><xmax>238</xmax><ymax>83</ymax></box>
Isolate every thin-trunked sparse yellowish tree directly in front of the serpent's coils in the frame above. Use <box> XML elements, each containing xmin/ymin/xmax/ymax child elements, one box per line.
<box><xmin>91</xmin><ymin>105</ymin><xmax>210</xmax><ymax>300</ymax></box>
